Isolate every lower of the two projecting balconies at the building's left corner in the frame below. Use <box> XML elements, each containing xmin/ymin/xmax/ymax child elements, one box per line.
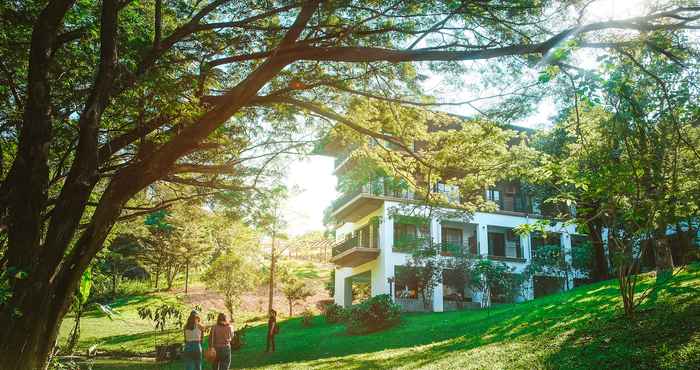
<box><xmin>331</xmin><ymin>223</ymin><xmax>379</xmax><ymax>267</ymax></box>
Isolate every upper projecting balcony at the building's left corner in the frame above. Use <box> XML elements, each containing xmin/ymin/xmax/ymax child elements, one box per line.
<box><xmin>332</xmin><ymin>179</ymin><xmax>417</xmax><ymax>222</ymax></box>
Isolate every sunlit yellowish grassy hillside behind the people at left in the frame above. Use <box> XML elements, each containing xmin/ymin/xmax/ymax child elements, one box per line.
<box><xmin>59</xmin><ymin>260</ymin><xmax>331</xmax><ymax>356</ymax></box>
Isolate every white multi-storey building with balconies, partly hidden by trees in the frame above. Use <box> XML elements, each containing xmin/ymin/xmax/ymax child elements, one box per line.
<box><xmin>324</xmin><ymin>134</ymin><xmax>583</xmax><ymax>312</ymax></box>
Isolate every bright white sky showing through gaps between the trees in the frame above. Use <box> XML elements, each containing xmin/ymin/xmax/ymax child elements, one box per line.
<box><xmin>283</xmin><ymin>0</ymin><xmax>648</xmax><ymax>236</ymax></box>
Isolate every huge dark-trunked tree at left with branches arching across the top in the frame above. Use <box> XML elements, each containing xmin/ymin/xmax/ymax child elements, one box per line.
<box><xmin>0</xmin><ymin>0</ymin><xmax>700</xmax><ymax>369</ymax></box>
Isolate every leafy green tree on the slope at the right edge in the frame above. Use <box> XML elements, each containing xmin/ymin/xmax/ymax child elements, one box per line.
<box><xmin>540</xmin><ymin>41</ymin><xmax>700</xmax><ymax>316</ymax></box>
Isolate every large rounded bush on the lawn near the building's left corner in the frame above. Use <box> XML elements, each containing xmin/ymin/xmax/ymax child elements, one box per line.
<box><xmin>345</xmin><ymin>294</ymin><xmax>401</xmax><ymax>334</ymax></box>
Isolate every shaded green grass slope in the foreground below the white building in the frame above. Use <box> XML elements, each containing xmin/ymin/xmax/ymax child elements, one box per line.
<box><xmin>74</xmin><ymin>264</ymin><xmax>700</xmax><ymax>370</ymax></box>
